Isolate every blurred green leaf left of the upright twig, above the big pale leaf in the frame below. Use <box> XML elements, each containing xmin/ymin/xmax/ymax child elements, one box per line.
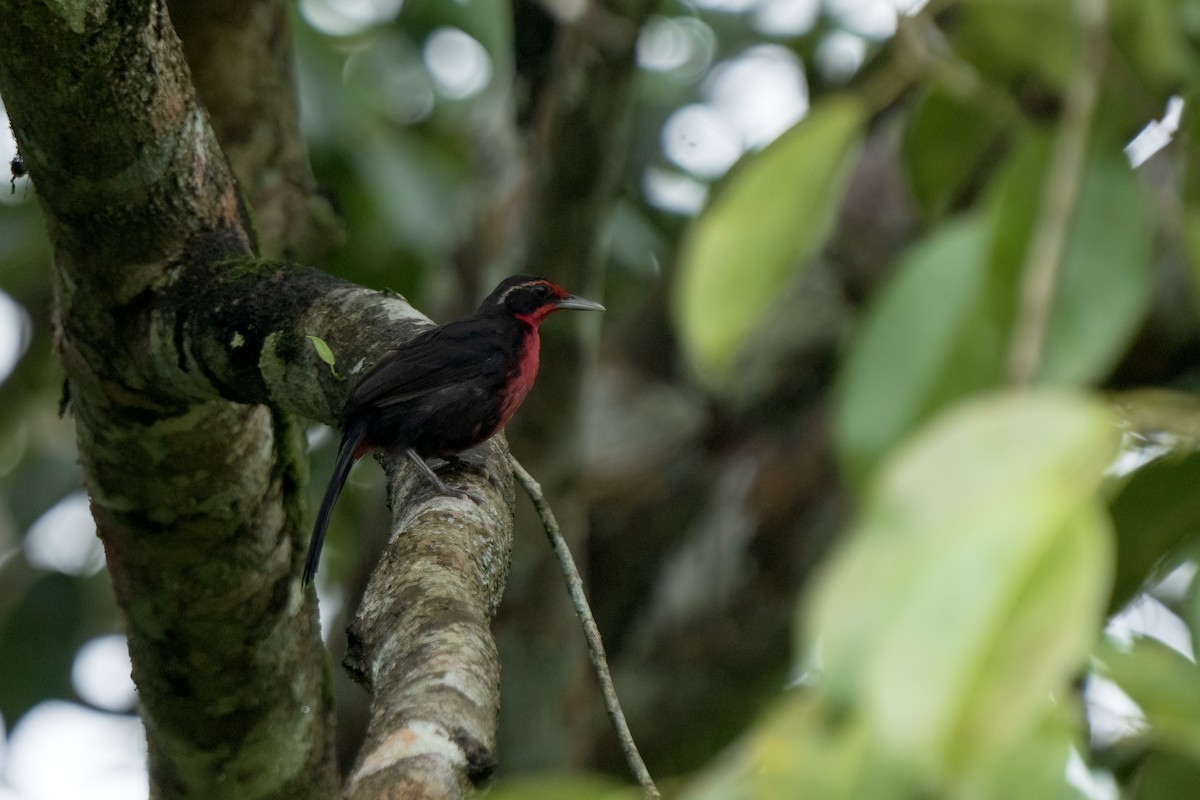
<box><xmin>834</xmin><ymin>216</ymin><xmax>1003</xmax><ymax>479</ymax></box>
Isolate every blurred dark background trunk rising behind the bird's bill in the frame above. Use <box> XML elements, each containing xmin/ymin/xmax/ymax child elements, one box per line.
<box><xmin>500</xmin><ymin>0</ymin><xmax>658</xmax><ymax>768</ymax></box>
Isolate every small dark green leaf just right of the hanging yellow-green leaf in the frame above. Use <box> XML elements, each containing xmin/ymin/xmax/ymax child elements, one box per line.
<box><xmin>904</xmin><ymin>86</ymin><xmax>997</xmax><ymax>217</ymax></box>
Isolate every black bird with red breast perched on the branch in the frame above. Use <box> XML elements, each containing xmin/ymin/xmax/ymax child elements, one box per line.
<box><xmin>304</xmin><ymin>275</ymin><xmax>604</xmax><ymax>584</ymax></box>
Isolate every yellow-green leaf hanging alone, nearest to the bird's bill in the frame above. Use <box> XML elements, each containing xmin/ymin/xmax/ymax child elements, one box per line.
<box><xmin>673</xmin><ymin>95</ymin><xmax>864</xmax><ymax>380</ymax></box>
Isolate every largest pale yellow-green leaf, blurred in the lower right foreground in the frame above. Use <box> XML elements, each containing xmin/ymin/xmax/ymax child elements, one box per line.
<box><xmin>808</xmin><ymin>392</ymin><xmax>1118</xmax><ymax>777</ymax></box>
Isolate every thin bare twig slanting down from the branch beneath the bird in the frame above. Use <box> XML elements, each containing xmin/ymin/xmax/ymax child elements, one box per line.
<box><xmin>509</xmin><ymin>456</ymin><xmax>662</xmax><ymax>800</ymax></box>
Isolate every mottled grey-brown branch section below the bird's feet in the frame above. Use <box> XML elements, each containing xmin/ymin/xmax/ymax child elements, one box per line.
<box><xmin>344</xmin><ymin>438</ymin><xmax>515</xmax><ymax>800</ymax></box>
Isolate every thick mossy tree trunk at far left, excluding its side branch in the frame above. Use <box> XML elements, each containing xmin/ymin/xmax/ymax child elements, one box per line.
<box><xmin>0</xmin><ymin>0</ymin><xmax>336</xmax><ymax>798</ymax></box>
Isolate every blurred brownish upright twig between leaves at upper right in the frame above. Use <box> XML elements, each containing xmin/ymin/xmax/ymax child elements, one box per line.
<box><xmin>1008</xmin><ymin>0</ymin><xmax>1108</xmax><ymax>386</ymax></box>
